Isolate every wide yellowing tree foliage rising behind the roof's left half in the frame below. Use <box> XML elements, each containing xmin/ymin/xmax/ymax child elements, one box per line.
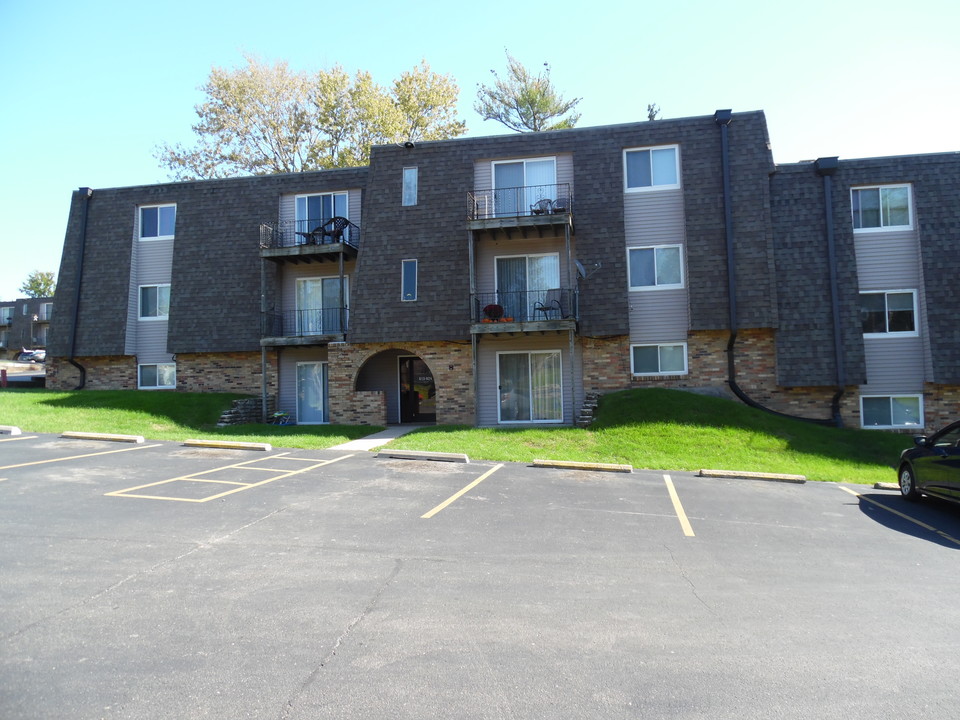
<box><xmin>157</xmin><ymin>56</ymin><xmax>467</xmax><ymax>180</ymax></box>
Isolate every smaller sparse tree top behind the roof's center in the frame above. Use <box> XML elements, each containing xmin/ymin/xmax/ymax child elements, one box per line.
<box><xmin>473</xmin><ymin>50</ymin><xmax>581</xmax><ymax>132</ymax></box>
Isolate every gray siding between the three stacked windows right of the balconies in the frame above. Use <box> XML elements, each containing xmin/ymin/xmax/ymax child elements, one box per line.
<box><xmin>623</xmin><ymin>190</ymin><xmax>690</xmax><ymax>343</ymax></box>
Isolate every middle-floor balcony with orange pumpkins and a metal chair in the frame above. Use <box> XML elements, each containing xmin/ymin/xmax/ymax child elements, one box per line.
<box><xmin>470</xmin><ymin>288</ymin><xmax>579</xmax><ymax>334</ymax></box>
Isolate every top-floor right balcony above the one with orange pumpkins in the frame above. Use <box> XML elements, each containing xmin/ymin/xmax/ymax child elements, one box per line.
<box><xmin>467</xmin><ymin>183</ymin><xmax>573</xmax><ymax>237</ymax></box>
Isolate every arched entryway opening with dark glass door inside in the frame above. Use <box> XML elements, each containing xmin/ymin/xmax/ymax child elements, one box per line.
<box><xmin>355</xmin><ymin>348</ymin><xmax>437</xmax><ymax>423</ymax></box>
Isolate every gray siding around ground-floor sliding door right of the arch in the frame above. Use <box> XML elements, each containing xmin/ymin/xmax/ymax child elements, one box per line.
<box><xmin>477</xmin><ymin>333</ymin><xmax>583</xmax><ymax>427</ymax></box>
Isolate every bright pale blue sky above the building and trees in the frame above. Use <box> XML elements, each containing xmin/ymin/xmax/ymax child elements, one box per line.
<box><xmin>0</xmin><ymin>0</ymin><xmax>960</xmax><ymax>300</ymax></box>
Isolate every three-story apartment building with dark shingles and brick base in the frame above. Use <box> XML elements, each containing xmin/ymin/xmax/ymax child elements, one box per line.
<box><xmin>47</xmin><ymin>111</ymin><xmax>960</xmax><ymax>429</ymax></box>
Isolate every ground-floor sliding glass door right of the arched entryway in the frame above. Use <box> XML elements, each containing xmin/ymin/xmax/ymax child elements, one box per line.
<box><xmin>497</xmin><ymin>350</ymin><xmax>563</xmax><ymax>423</ymax></box>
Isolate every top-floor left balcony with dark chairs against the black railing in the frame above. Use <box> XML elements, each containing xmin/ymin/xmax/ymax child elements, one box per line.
<box><xmin>260</xmin><ymin>217</ymin><xmax>360</xmax><ymax>262</ymax></box>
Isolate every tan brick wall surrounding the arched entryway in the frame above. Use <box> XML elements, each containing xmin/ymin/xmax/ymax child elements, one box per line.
<box><xmin>327</xmin><ymin>342</ymin><xmax>475</xmax><ymax>425</ymax></box>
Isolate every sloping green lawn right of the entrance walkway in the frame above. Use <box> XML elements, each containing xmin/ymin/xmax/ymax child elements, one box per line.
<box><xmin>390</xmin><ymin>389</ymin><xmax>913</xmax><ymax>483</ymax></box>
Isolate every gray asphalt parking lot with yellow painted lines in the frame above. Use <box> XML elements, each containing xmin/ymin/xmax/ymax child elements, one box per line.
<box><xmin>0</xmin><ymin>434</ymin><xmax>960</xmax><ymax>720</ymax></box>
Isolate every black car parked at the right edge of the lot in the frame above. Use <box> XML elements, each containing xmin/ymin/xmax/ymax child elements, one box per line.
<box><xmin>898</xmin><ymin>421</ymin><xmax>960</xmax><ymax>502</ymax></box>
